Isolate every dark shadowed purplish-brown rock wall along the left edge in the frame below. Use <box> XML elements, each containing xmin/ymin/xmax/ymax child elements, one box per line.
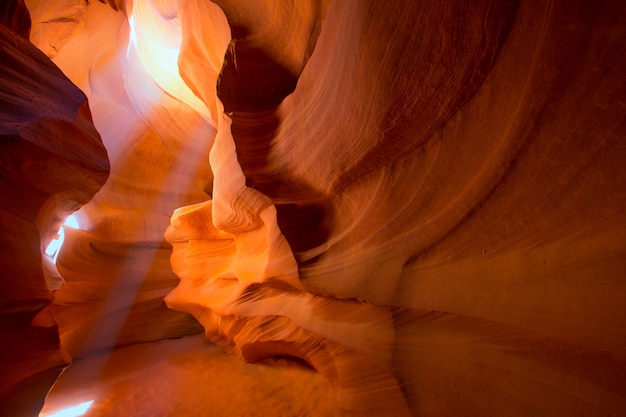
<box><xmin>0</xmin><ymin>1</ymin><xmax>109</xmax><ymax>416</ymax></box>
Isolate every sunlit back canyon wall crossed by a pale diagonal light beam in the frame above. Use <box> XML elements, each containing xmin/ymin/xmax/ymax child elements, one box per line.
<box><xmin>25</xmin><ymin>2</ymin><xmax>215</xmax><ymax>357</ymax></box>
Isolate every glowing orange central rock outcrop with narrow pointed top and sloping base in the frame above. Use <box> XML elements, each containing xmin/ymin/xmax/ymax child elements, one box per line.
<box><xmin>166</xmin><ymin>112</ymin><xmax>409</xmax><ymax>415</ymax></box>
